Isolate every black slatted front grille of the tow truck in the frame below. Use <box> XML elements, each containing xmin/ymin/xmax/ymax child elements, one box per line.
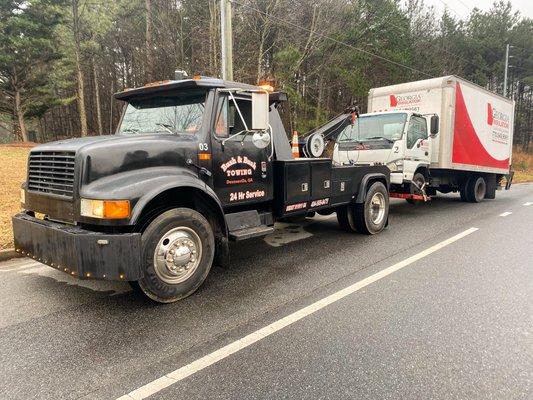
<box><xmin>28</xmin><ymin>151</ymin><xmax>75</xmax><ymax>197</ymax></box>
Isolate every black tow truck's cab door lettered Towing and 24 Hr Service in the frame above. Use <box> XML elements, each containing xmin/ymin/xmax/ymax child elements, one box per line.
<box><xmin>210</xmin><ymin>93</ymin><xmax>273</xmax><ymax>206</ymax></box>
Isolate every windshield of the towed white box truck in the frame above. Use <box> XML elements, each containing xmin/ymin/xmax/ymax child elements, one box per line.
<box><xmin>337</xmin><ymin>113</ymin><xmax>407</xmax><ymax>142</ymax></box>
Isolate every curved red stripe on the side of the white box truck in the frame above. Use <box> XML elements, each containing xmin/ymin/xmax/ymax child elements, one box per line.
<box><xmin>452</xmin><ymin>82</ymin><xmax>509</xmax><ymax>169</ymax></box>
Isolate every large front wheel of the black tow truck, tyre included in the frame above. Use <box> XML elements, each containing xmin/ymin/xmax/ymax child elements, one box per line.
<box><xmin>132</xmin><ymin>208</ymin><xmax>215</xmax><ymax>303</ymax></box>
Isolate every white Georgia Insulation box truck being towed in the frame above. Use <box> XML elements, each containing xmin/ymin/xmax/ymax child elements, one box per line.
<box><xmin>333</xmin><ymin>76</ymin><xmax>514</xmax><ymax>202</ymax></box>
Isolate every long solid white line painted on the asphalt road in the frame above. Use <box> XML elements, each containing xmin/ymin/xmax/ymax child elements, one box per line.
<box><xmin>117</xmin><ymin>228</ymin><xmax>478</xmax><ymax>400</ymax></box>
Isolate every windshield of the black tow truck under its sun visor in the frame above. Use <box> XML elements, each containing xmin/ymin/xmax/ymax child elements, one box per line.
<box><xmin>118</xmin><ymin>95</ymin><xmax>205</xmax><ymax>134</ymax></box>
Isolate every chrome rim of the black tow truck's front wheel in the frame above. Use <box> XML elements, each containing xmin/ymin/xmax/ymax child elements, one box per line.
<box><xmin>154</xmin><ymin>226</ymin><xmax>202</xmax><ymax>285</ymax></box>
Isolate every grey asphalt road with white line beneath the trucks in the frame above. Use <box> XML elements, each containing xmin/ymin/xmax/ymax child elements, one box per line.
<box><xmin>0</xmin><ymin>185</ymin><xmax>533</xmax><ymax>399</ymax></box>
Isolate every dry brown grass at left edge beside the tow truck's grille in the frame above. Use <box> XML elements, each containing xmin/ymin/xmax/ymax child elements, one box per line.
<box><xmin>0</xmin><ymin>146</ymin><xmax>30</xmax><ymax>249</ymax></box>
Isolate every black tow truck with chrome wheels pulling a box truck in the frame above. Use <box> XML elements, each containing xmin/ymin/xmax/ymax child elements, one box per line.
<box><xmin>13</xmin><ymin>77</ymin><xmax>389</xmax><ymax>303</ymax></box>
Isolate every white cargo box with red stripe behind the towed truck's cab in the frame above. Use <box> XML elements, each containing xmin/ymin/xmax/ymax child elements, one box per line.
<box><xmin>368</xmin><ymin>76</ymin><xmax>514</xmax><ymax>174</ymax></box>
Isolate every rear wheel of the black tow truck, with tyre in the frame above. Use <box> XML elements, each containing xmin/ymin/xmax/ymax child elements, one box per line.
<box><xmin>354</xmin><ymin>182</ymin><xmax>389</xmax><ymax>235</ymax></box>
